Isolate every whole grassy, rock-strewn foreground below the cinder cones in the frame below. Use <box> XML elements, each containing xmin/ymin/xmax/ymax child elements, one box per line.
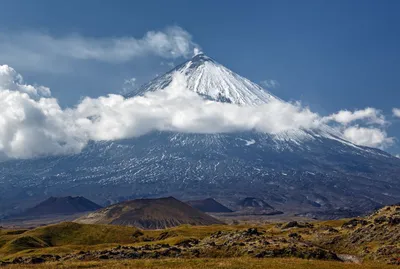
<box><xmin>0</xmin><ymin>206</ymin><xmax>400</xmax><ymax>269</ymax></box>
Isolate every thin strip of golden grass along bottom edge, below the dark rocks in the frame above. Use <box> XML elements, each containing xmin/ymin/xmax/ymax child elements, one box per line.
<box><xmin>3</xmin><ymin>258</ymin><xmax>398</xmax><ymax>269</ymax></box>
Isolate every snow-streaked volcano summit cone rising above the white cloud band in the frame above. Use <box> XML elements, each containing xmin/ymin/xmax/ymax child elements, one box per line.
<box><xmin>128</xmin><ymin>53</ymin><xmax>277</xmax><ymax>106</ymax></box>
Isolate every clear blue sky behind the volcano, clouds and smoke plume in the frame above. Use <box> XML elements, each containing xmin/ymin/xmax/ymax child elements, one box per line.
<box><xmin>0</xmin><ymin>0</ymin><xmax>400</xmax><ymax>153</ymax></box>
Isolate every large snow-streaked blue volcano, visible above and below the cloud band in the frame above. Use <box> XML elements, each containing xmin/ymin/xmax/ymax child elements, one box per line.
<box><xmin>0</xmin><ymin>54</ymin><xmax>400</xmax><ymax>218</ymax></box>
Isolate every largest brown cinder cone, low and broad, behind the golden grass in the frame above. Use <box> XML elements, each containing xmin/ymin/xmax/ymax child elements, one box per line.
<box><xmin>76</xmin><ymin>197</ymin><xmax>222</xmax><ymax>229</ymax></box>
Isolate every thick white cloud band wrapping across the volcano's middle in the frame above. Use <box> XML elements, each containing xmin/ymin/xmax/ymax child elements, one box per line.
<box><xmin>0</xmin><ymin>65</ymin><xmax>391</xmax><ymax>158</ymax></box>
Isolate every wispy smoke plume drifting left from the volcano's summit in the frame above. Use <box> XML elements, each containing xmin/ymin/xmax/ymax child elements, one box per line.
<box><xmin>0</xmin><ymin>26</ymin><xmax>198</xmax><ymax>71</ymax></box>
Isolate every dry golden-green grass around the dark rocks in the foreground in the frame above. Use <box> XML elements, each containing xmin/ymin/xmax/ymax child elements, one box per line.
<box><xmin>0</xmin><ymin>220</ymin><xmax>396</xmax><ymax>269</ymax></box>
